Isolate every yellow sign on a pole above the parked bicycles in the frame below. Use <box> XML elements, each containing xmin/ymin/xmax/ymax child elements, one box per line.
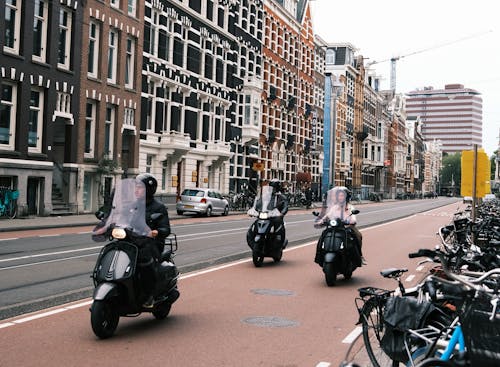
<box><xmin>460</xmin><ymin>149</ymin><xmax>490</xmax><ymax>198</ymax></box>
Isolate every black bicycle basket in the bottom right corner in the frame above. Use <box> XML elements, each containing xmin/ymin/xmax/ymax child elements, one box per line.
<box><xmin>460</xmin><ymin>294</ymin><xmax>500</xmax><ymax>367</ymax></box>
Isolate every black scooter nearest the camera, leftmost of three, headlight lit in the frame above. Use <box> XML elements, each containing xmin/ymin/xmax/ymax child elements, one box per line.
<box><xmin>90</xmin><ymin>213</ymin><xmax>179</xmax><ymax>339</ymax></box>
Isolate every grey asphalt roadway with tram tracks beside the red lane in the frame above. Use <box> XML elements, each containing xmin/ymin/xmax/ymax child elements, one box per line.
<box><xmin>0</xmin><ymin>198</ymin><xmax>458</xmax><ymax>320</ymax></box>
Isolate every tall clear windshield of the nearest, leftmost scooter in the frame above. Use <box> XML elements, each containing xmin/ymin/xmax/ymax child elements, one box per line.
<box><xmin>94</xmin><ymin>178</ymin><xmax>150</xmax><ymax>236</ymax></box>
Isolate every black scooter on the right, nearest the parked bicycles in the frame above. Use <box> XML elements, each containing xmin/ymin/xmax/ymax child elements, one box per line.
<box><xmin>313</xmin><ymin>210</ymin><xmax>361</xmax><ymax>287</ymax></box>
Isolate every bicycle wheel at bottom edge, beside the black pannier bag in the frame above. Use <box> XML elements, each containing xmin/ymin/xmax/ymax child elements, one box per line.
<box><xmin>361</xmin><ymin>298</ymin><xmax>399</xmax><ymax>367</ymax></box>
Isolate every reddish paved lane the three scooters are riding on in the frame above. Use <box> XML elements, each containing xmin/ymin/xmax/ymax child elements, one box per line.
<box><xmin>0</xmin><ymin>202</ymin><xmax>456</xmax><ymax>367</ymax></box>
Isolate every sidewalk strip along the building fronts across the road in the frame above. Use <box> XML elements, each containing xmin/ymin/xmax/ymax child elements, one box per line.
<box><xmin>0</xmin><ymin>201</ymin><xmax>378</xmax><ymax>232</ymax></box>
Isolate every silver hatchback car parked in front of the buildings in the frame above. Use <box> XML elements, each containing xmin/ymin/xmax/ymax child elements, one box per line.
<box><xmin>176</xmin><ymin>188</ymin><xmax>229</xmax><ymax>217</ymax></box>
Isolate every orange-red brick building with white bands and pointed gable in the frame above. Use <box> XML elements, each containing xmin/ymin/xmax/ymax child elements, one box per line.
<box><xmin>259</xmin><ymin>0</ymin><xmax>322</xmax><ymax>191</ymax></box>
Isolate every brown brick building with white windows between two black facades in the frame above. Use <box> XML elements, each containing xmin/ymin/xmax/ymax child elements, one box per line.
<box><xmin>74</xmin><ymin>0</ymin><xmax>144</xmax><ymax>212</ymax></box>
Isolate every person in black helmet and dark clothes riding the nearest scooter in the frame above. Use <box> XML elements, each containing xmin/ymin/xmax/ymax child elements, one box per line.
<box><xmin>136</xmin><ymin>173</ymin><xmax>170</xmax><ymax>307</ymax></box>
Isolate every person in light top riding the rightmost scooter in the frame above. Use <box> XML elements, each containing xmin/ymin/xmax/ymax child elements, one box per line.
<box><xmin>314</xmin><ymin>186</ymin><xmax>366</xmax><ymax>265</ymax></box>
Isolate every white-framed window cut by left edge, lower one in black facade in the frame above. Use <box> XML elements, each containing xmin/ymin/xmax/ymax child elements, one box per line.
<box><xmin>0</xmin><ymin>83</ymin><xmax>17</xmax><ymax>150</ymax></box>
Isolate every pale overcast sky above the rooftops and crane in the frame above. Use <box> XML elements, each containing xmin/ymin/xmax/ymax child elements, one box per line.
<box><xmin>311</xmin><ymin>0</ymin><xmax>500</xmax><ymax>156</ymax></box>
